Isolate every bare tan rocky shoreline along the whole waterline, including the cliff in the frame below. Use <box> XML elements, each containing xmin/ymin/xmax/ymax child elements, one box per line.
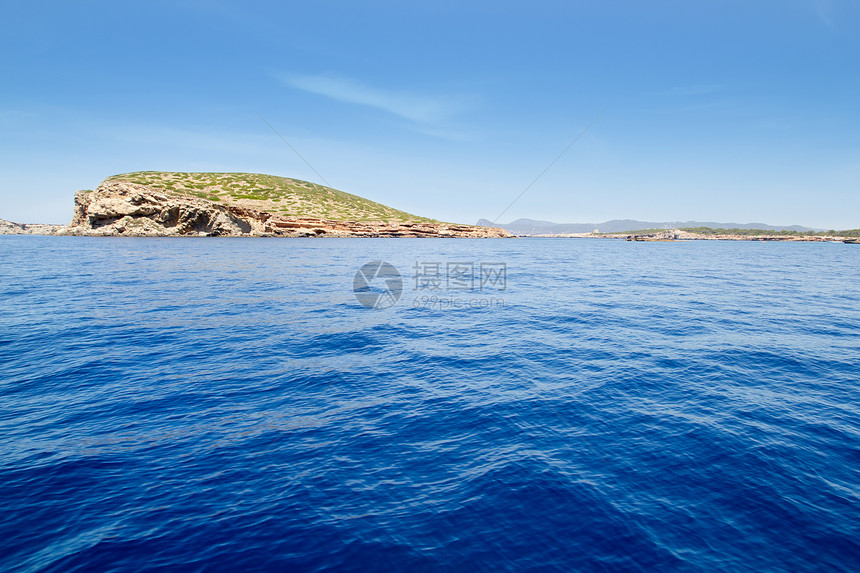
<box><xmin>0</xmin><ymin>179</ymin><xmax>860</xmax><ymax>243</ymax></box>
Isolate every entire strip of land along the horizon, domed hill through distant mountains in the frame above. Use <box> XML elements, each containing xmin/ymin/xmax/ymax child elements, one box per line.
<box><xmin>5</xmin><ymin>171</ymin><xmax>860</xmax><ymax>240</ymax></box>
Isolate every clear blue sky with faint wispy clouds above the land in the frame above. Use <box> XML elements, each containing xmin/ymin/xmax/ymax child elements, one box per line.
<box><xmin>0</xmin><ymin>0</ymin><xmax>860</xmax><ymax>229</ymax></box>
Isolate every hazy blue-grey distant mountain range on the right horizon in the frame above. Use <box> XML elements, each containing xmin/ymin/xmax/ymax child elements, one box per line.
<box><xmin>477</xmin><ymin>219</ymin><xmax>815</xmax><ymax>235</ymax></box>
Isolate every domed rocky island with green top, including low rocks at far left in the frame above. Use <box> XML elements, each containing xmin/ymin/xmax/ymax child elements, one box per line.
<box><xmin>0</xmin><ymin>171</ymin><xmax>511</xmax><ymax>238</ymax></box>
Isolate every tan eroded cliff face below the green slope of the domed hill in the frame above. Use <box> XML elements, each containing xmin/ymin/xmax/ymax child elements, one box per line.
<box><xmin>67</xmin><ymin>180</ymin><xmax>510</xmax><ymax>237</ymax></box>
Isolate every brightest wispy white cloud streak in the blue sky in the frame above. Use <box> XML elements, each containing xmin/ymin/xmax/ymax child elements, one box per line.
<box><xmin>277</xmin><ymin>74</ymin><xmax>469</xmax><ymax>125</ymax></box>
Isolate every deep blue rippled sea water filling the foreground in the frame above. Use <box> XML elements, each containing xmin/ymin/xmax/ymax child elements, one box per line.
<box><xmin>0</xmin><ymin>236</ymin><xmax>860</xmax><ymax>572</ymax></box>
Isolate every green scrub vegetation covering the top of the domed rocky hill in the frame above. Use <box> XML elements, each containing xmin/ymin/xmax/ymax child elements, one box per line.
<box><xmin>107</xmin><ymin>171</ymin><xmax>438</xmax><ymax>223</ymax></box>
